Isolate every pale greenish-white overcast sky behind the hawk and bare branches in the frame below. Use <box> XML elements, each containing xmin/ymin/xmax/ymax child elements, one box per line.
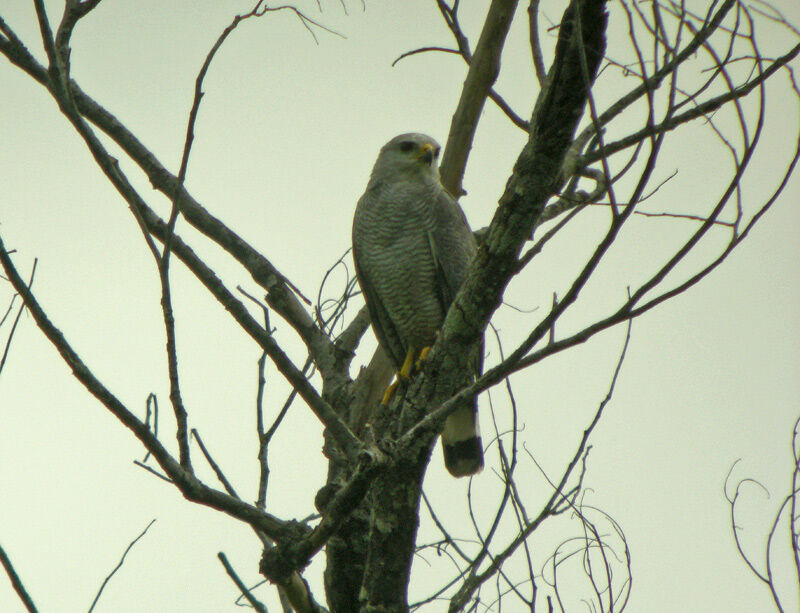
<box><xmin>0</xmin><ymin>0</ymin><xmax>800</xmax><ymax>613</ymax></box>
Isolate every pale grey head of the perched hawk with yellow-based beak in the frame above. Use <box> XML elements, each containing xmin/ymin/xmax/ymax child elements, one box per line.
<box><xmin>372</xmin><ymin>133</ymin><xmax>441</xmax><ymax>182</ymax></box>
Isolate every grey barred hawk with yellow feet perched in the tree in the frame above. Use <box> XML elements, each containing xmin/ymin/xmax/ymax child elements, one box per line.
<box><xmin>353</xmin><ymin>133</ymin><xmax>483</xmax><ymax>477</ymax></box>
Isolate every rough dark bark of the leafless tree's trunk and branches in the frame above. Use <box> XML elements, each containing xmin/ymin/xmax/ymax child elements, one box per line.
<box><xmin>0</xmin><ymin>0</ymin><xmax>800</xmax><ymax>613</ymax></box>
